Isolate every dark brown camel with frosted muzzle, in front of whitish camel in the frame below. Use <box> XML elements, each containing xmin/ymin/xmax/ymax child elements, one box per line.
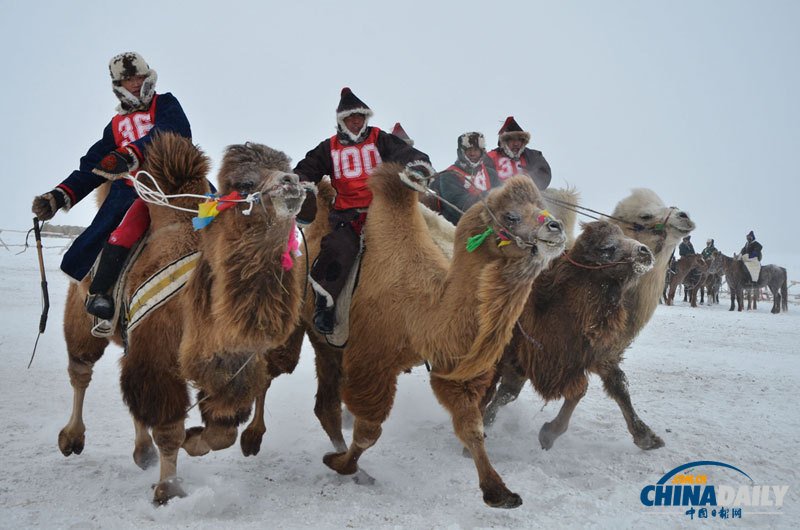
<box><xmin>476</xmin><ymin>221</ymin><xmax>658</xmax><ymax>449</ymax></box>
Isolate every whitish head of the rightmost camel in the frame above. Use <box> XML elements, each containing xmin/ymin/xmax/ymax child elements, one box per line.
<box><xmin>612</xmin><ymin>188</ymin><xmax>695</xmax><ymax>254</ymax></box>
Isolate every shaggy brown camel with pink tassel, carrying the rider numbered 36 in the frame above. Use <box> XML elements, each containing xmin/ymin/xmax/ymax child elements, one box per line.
<box><xmin>59</xmin><ymin>133</ymin><xmax>305</xmax><ymax>504</ymax></box>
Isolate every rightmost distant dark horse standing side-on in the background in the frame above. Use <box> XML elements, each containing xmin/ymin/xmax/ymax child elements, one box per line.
<box><xmin>712</xmin><ymin>252</ymin><xmax>789</xmax><ymax>313</ymax></box>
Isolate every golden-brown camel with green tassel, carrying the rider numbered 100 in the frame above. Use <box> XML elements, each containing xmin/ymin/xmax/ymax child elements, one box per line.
<box><xmin>317</xmin><ymin>165</ymin><xmax>566</xmax><ymax>508</ymax></box>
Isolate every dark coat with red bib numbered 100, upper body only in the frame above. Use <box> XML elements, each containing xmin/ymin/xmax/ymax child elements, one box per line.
<box><xmin>294</xmin><ymin>127</ymin><xmax>430</xmax><ymax>210</ymax></box>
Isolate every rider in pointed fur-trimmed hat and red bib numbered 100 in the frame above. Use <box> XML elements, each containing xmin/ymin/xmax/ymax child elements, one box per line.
<box><xmin>294</xmin><ymin>88</ymin><xmax>433</xmax><ymax>334</ymax></box>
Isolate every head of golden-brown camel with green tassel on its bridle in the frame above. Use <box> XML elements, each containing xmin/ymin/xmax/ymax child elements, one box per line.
<box><xmin>456</xmin><ymin>176</ymin><xmax>567</xmax><ymax>263</ymax></box>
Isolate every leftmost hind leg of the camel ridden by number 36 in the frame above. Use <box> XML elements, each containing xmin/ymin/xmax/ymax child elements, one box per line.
<box><xmin>58</xmin><ymin>284</ymin><xmax>108</xmax><ymax>456</ymax></box>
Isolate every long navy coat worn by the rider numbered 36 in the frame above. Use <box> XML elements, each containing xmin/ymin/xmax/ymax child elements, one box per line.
<box><xmin>58</xmin><ymin>92</ymin><xmax>192</xmax><ymax>281</ymax></box>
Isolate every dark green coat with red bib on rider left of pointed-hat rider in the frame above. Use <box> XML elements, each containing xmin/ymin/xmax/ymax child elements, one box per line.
<box><xmin>435</xmin><ymin>158</ymin><xmax>503</xmax><ymax>224</ymax></box>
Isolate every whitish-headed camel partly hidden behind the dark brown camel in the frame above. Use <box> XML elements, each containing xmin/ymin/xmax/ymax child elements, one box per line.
<box><xmin>487</xmin><ymin>189</ymin><xmax>695</xmax><ymax>449</ymax></box>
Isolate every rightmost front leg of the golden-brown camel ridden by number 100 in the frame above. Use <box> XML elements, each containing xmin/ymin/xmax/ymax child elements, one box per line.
<box><xmin>431</xmin><ymin>373</ymin><xmax>522</xmax><ymax>508</ymax></box>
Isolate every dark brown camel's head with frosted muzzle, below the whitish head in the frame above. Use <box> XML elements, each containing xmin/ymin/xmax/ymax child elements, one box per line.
<box><xmin>568</xmin><ymin>221</ymin><xmax>655</xmax><ymax>281</ymax></box>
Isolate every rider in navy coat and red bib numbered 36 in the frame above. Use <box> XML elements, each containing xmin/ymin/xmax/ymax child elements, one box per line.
<box><xmin>32</xmin><ymin>52</ymin><xmax>192</xmax><ymax>319</ymax></box>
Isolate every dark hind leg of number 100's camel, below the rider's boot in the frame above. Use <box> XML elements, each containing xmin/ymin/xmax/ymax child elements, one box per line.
<box><xmin>308</xmin><ymin>333</ymin><xmax>346</xmax><ymax>453</ymax></box>
